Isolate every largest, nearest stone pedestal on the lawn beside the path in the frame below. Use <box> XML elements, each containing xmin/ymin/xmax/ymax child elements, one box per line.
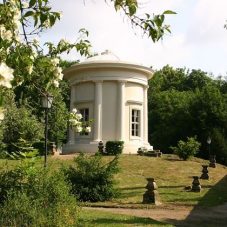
<box><xmin>143</xmin><ymin>178</ymin><xmax>161</xmax><ymax>205</ymax></box>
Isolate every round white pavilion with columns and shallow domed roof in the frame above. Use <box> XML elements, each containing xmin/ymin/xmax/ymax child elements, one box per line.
<box><xmin>62</xmin><ymin>51</ymin><xmax>153</xmax><ymax>154</ymax></box>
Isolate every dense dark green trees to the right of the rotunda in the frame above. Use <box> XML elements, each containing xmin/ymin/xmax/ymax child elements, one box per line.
<box><xmin>148</xmin><ymin>65</ymin><xmax>227</xmax><ymax>164</ymax></box>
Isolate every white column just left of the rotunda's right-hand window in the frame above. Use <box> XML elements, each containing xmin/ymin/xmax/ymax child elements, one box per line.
<box><xmin>118</xmin><ymin>81</ymin><xmax>125</xmax><ymax>141</ymax></box>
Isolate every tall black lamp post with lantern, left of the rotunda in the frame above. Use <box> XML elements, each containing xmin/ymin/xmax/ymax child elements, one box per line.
<box><xmin>42</xmin><ymin>94</ymin><xmax>53</xmax><ymax>167</ymax></box>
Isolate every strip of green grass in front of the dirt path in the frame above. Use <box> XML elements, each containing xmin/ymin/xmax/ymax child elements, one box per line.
<box><xmin>80</xmin><ymin>210</ymin><xmax>172</xmax><ymax>227</ymax></box>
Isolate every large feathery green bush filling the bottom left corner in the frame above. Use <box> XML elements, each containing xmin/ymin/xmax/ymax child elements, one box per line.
<box><xmin>0</xmin><ymin>160</ymin><xmax>78</xmax><ymax>227</ymax></box>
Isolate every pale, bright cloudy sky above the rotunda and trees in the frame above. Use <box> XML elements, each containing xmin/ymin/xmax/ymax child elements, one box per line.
<box><xmin>42</xmin><ymin>0</ymin><xmax>227</xmax><ymax>76</ymax></box>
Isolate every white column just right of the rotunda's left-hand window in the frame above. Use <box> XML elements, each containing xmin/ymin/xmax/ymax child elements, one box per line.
<box><xmin>94</xmin><ymin>81</ymin><xmax>102</xmax><ymax>141</ymax></box>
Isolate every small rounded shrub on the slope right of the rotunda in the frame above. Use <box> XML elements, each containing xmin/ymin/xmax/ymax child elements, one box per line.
<box><xmin>170</xmin><ymin>137</ymin><xmax>201</xmax><ymax>160</ymax></box>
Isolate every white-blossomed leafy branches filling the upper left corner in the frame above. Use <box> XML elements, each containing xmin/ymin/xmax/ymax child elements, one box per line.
<box><xmin>0</xmin><ymin>0</ymin><xmax>90</xmax><ymax>97</ymax></box>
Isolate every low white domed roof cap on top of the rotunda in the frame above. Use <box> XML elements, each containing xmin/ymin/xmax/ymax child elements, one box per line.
<box><xmin>81</xmin><ymin>50</ymin><xmax>121</xmax><ymax>64</ymax></box>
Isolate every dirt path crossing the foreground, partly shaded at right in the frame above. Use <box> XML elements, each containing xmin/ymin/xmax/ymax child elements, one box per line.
<box><xmin>84</xmin><ymin>204</ymin><xmax>227</xmax><ymax>227</ymax></box>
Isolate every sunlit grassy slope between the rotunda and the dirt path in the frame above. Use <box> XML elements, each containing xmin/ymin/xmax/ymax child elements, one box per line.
<box><xmin>0</xmin><ymin>155</ymin><xmax>227</xmax><ymax>207</ymax></box>
